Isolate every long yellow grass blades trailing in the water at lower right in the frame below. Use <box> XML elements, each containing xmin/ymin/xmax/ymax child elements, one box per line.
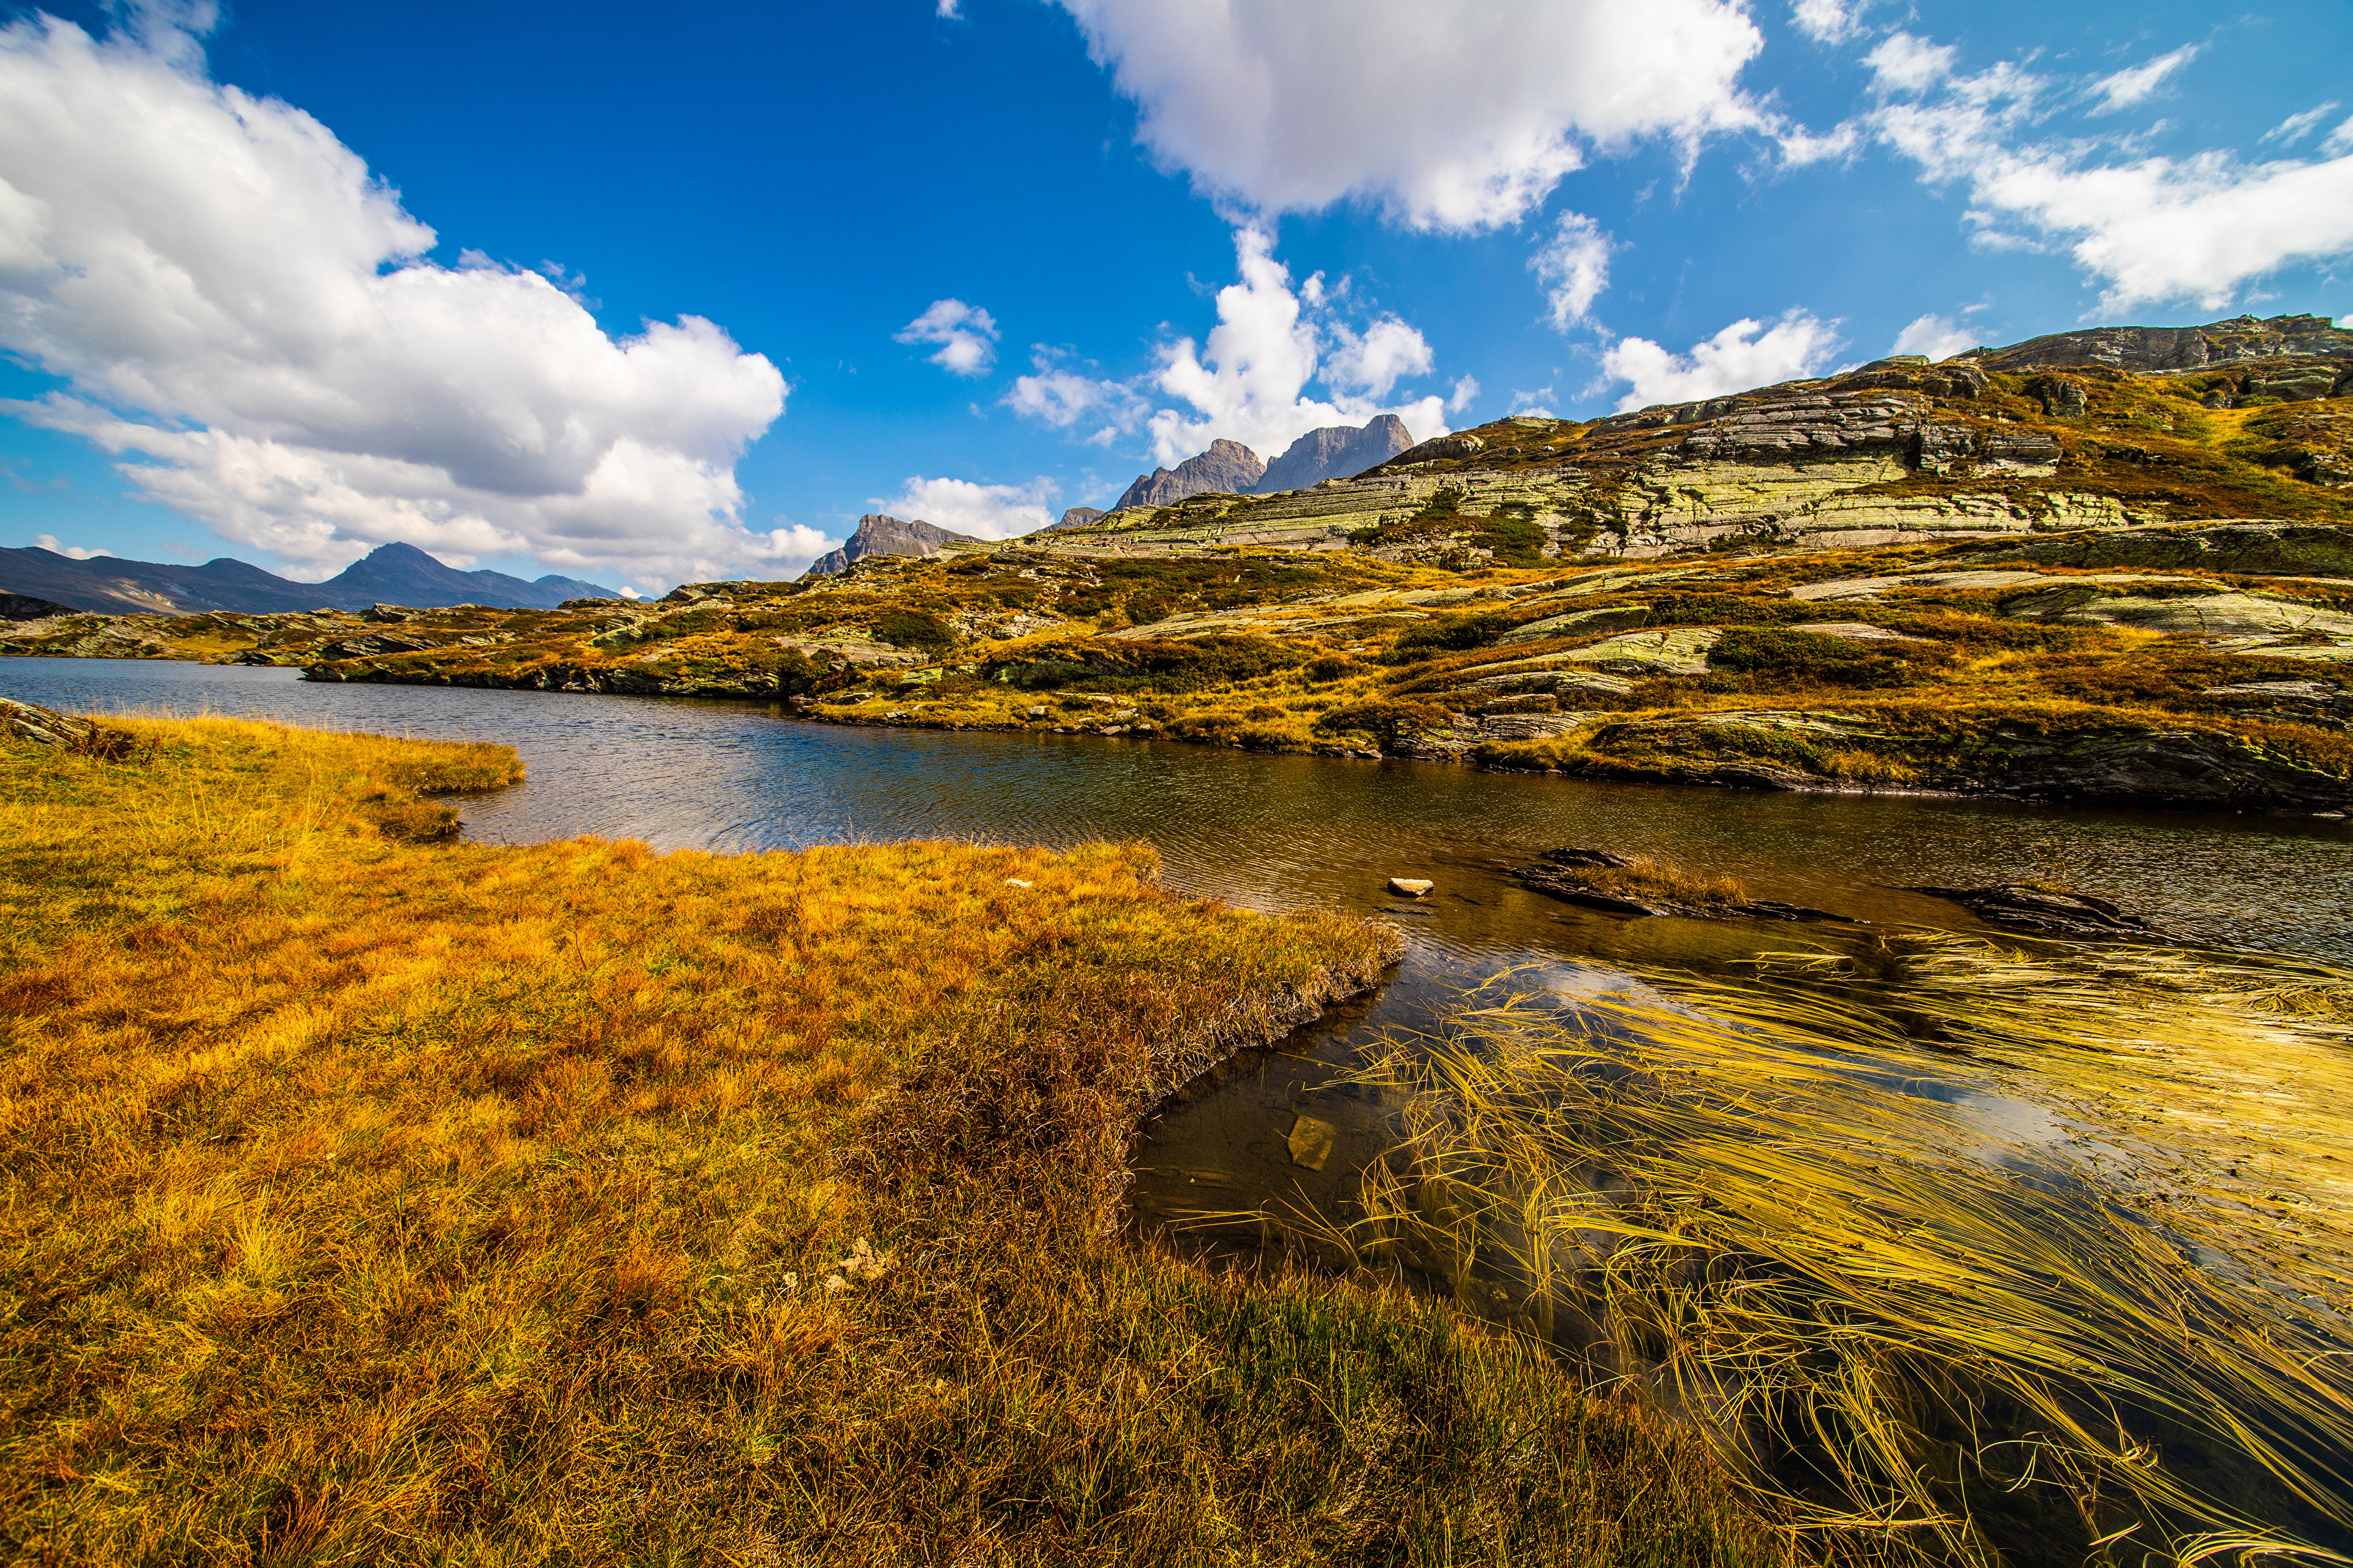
<box><xmin>1327</xmin><ymin>937</ymin><xmax>2353</xmax><ymax>1563</ymax></box>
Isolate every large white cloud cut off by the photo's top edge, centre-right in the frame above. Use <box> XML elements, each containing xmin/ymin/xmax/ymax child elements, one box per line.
<box><xmin>1059</xmin><ymin>0</ymin><xmax>1765</xmax><ymax>231</ymax></box>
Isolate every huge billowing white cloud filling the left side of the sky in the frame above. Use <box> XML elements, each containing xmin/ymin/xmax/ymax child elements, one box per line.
<box><xmin>0</xmin><ymin>7</ymin><xmax>809</xmax><ymax>579</ymax></box>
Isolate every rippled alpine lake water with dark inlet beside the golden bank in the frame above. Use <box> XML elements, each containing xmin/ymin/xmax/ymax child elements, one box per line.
<box><xmin>18</xmin><ymin>659</ymin><xmax>2353</xmax><ymax>1561</ymax></box>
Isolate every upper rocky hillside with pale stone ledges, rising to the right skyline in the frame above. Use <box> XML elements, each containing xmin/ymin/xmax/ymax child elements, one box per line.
<box><xmin>1056</xmin><ymin>316</ymin><xmax>2353</xmax><ymax>565</ymax></box>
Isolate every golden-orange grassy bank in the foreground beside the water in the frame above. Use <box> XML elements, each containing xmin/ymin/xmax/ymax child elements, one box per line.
<box><xmin>0</xmin><ymin>721</ymin><xmax>1788</xmax><ymax>1566</ymax></box>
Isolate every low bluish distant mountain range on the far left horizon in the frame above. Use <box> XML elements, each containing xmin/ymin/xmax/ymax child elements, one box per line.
<box><xmin>0</xmin><ymin>544</ymin><xmax>612</xmax><ymax>615</ymax></box>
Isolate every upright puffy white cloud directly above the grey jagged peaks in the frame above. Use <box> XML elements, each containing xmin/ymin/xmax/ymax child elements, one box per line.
<box><xmin>1151</xmin><ymin>229</ymin><xmax>1447</xmax><ymax>466</ymax></box>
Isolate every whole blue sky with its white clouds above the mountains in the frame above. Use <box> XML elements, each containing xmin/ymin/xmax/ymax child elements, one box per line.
<box><xmin>0</xmin><ymin>0</ymin><xmax>2353</xmax><ymax>591</ymax></box>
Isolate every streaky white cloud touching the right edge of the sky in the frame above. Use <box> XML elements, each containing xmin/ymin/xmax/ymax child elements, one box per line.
<box><xmin>1873</xmin><ymin>36</ymin><xmax>2353</xmax><ymax>311</ymax></box>
